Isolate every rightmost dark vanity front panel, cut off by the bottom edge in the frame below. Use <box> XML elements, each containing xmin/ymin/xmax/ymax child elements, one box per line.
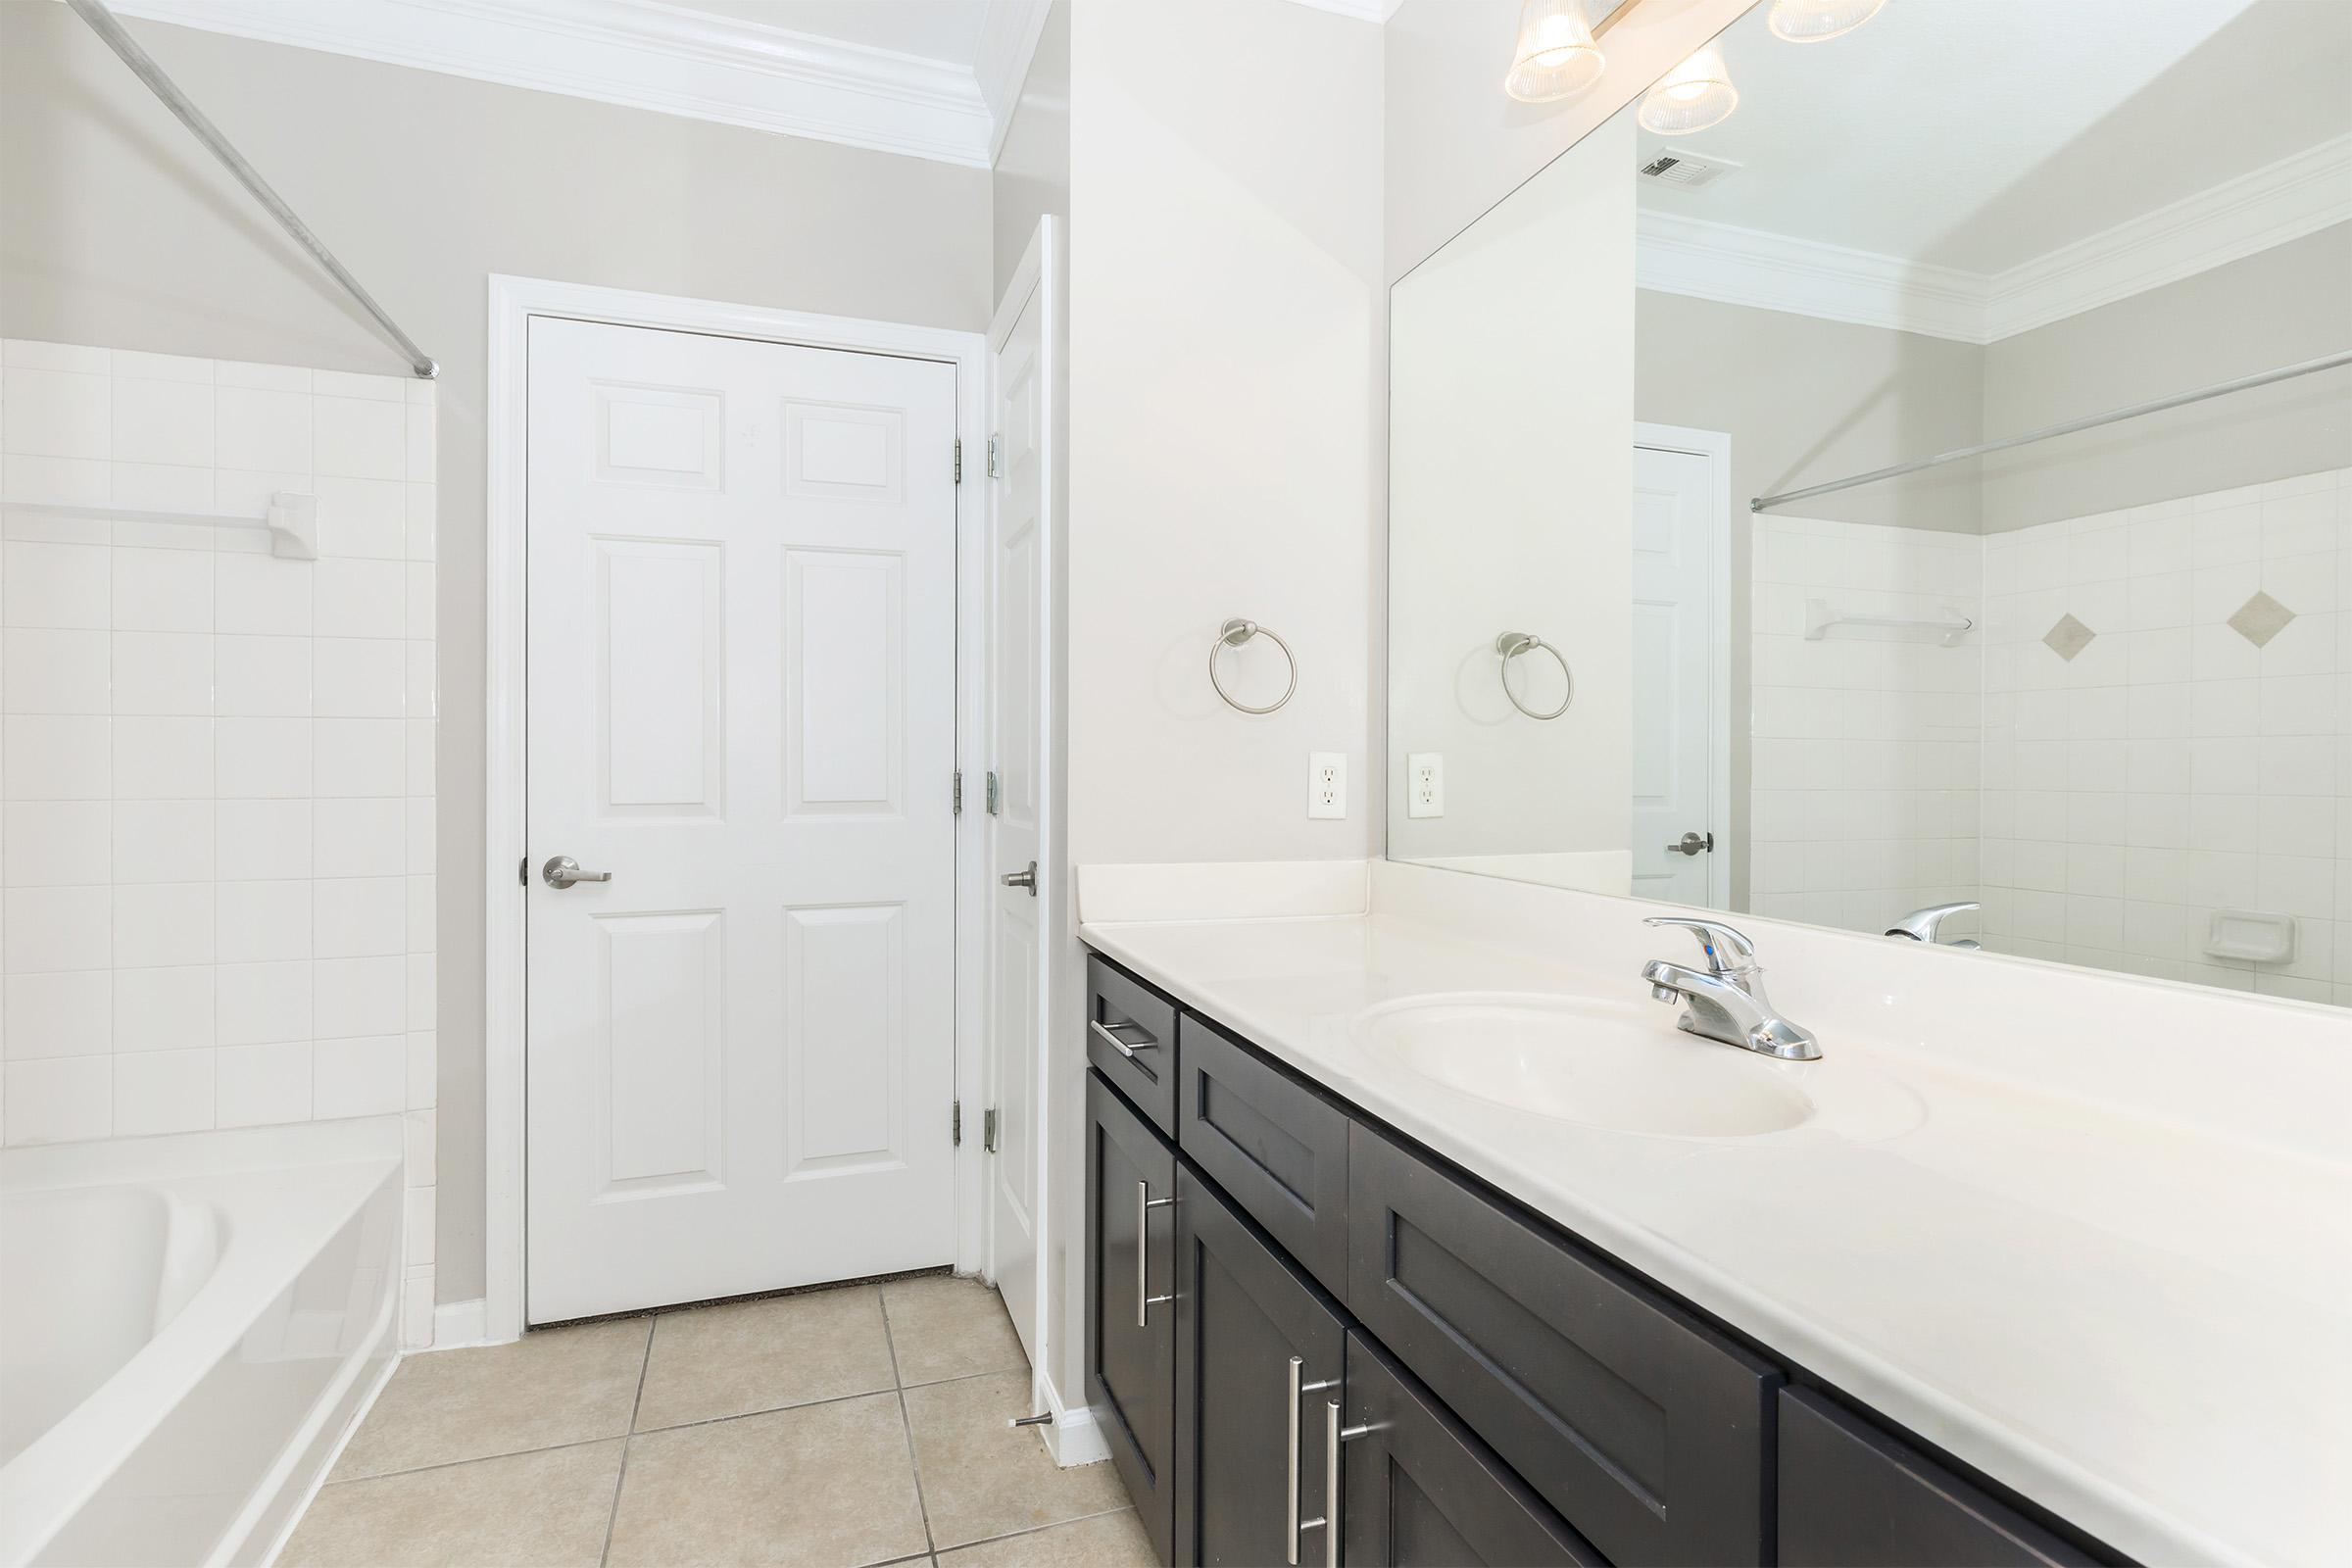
<box><xmin>1781</xmin><ymin>1390</ymin><xmax>2093</xmax><ymax>1568</ymax></box>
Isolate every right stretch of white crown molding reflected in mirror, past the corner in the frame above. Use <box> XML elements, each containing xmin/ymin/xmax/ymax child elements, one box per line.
<box><xmin>1985</xmin><ymin>136</ymin><xmax>2352</xmax><ymax>341</ymax></box>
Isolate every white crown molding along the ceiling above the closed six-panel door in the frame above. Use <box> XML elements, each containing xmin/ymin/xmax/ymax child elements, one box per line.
<box><xmin>98</xmin><ymin>0</ymin><xmax>995</xmax><ymax>170</ymax></box>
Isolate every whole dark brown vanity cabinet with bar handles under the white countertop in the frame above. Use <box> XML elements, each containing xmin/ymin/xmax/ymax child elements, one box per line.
<box><xmin>1087</xmin><ymin>959</ymin><xmax>2122</xmax><ymax>1568</ymax></box>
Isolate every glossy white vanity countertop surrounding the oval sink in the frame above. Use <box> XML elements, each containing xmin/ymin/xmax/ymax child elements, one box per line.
<box><xmin>1080</xmin><ymin>869</ymin><xmax>2352</xmax><ymax>1566</ymax></box>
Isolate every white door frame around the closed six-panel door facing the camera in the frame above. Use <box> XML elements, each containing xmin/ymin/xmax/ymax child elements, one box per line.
<box><xmin>482</xmin><ymin>272</ymin><xmax>988</xmax><ymax>1343</ymax></box>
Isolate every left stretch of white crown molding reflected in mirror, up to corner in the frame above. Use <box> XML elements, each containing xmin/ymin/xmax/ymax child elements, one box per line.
<box><xmin>1635</xmin><ymin>209</ymin><xmax>1987</xmax><ymax>343</ymax></box>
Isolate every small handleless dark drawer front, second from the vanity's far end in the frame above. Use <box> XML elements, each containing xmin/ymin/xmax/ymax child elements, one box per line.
<box><xmin>1176</xmin><ymin>1015</ymin><xmax>1348</xmax><ymax>1300</ymax></box>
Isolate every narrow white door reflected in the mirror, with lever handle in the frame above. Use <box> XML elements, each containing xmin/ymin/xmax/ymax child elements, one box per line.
<box><xmin>1633</xmin><ymin>425</ymin><xmax>1731</xmax><ymax>907</ymax></box>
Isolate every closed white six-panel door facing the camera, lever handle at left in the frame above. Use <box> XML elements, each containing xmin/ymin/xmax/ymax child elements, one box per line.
<box><xmin>524</xmin><ymin>318</ymin><xmax>955</xmax><ymax>1324</ymax></box>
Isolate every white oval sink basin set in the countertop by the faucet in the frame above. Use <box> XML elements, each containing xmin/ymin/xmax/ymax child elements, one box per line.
<box><xmin>1357</xmin><ymin>997</ymin><xmax>1919</xmax><ymax>1138</ymax></box>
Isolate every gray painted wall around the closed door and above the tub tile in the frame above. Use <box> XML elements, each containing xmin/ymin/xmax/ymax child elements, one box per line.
<box><xmin>0</xmin><ymin>5</ymin><xmax>995</xmax><ymax>1300</ymax></box>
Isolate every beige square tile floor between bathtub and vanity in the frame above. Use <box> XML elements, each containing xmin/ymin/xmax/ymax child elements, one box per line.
<box><xmin>277</xmin><ymin>1277</ymin><xmax>1152</xmax><ymax>1568</ymax></box>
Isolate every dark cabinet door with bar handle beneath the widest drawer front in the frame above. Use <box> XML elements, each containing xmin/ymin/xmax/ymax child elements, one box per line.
<box><xmin>1341</xmin><ymin>1333</ymin><xmax>1606</xmax><ymax>1568</ymax></box>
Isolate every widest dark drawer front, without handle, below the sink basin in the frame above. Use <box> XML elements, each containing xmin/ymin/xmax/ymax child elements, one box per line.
<box><xmin>1348</xmin><ymin>1124</ymin><xmax>1783</xmax><ymax>1568</ymax></box>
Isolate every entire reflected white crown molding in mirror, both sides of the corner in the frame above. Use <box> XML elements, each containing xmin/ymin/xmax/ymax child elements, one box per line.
<box><xmin>1635</xmin><ymin>136</ymin><xmax>2352</xmax><ymax>343</ymax></box>
